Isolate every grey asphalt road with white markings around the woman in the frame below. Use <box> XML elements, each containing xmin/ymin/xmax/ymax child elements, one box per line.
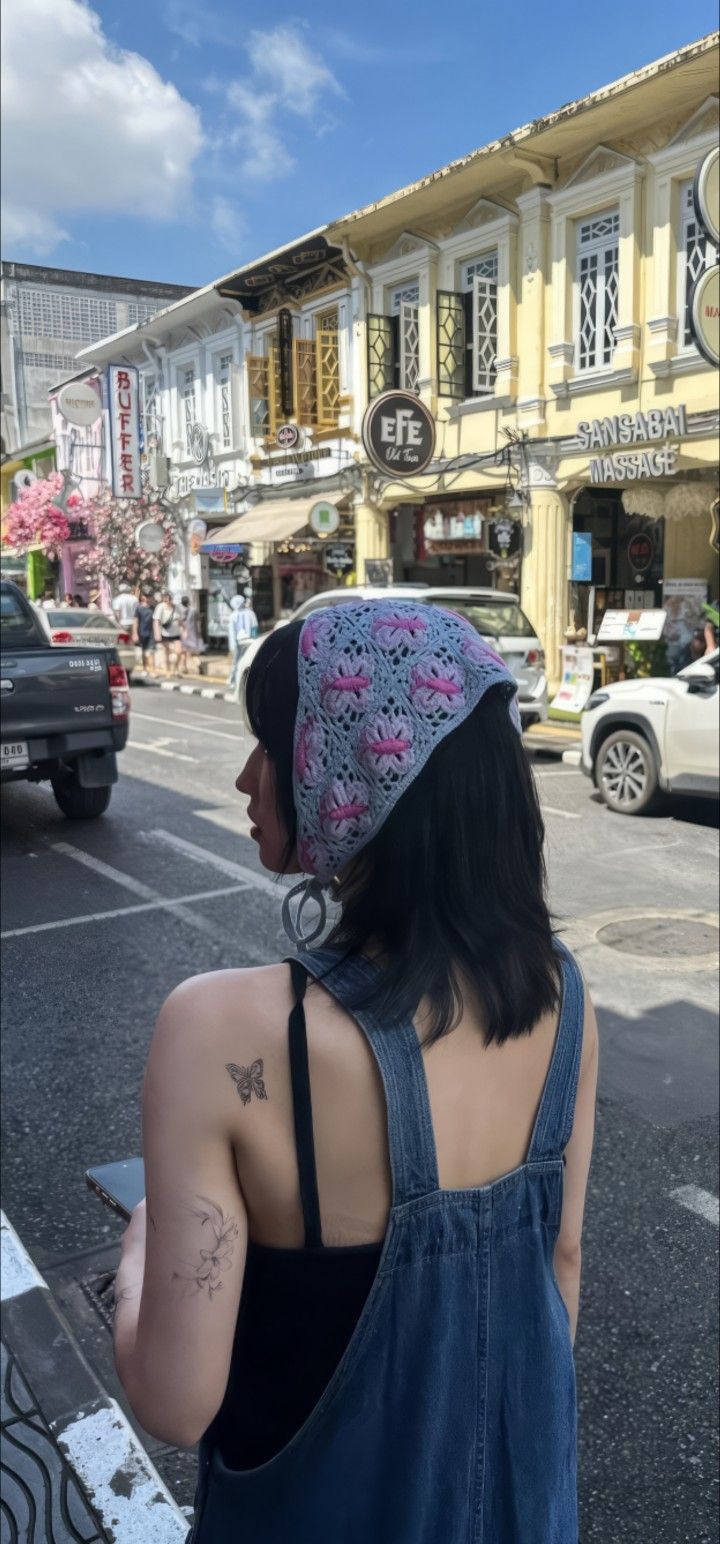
<box><xmin>2</xmin><ymin>687</ymin><xmax>718</xmax><ymax>1544</ymax></box>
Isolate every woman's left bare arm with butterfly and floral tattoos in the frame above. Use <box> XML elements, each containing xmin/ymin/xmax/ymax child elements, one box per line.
<box><xmin>114</xmin><ymin>979</ymin><xmax>247</xmax><ymax>1447</ymax></box>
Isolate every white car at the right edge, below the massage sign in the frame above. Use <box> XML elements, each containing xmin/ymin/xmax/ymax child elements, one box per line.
<box><xmin>581</xmin><ymin>648</ymin><xmax>720</xmax><ymax>815</ymax></box>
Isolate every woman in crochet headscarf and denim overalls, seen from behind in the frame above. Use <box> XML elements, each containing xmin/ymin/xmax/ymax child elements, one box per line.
<box><xmin>116</xmin><ymin>602</ymin><xmax>596</xmax><ymax>1544</ymax></box>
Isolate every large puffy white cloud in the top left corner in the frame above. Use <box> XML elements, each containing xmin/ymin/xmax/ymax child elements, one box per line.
<box><xmin>2</xmin><ymin>0</ymin><xmax>202</xmax><ymax>255</ymax></box>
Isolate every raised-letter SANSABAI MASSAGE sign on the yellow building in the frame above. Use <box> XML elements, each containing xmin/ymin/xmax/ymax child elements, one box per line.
<box><xmin>578</xmin><ymin>406</ymin><xmax>688</xmax><ymax>483</ymax></box>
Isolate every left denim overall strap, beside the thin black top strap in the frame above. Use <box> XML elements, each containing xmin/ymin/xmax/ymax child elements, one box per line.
<box><xmin>290</xmin><ymin>948</ymin><xmax>439</xmax><ymax>1206</ymax></box>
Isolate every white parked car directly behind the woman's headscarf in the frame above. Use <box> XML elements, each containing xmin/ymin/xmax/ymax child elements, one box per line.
<box><xmin>233</xmin><ymin>585</ymin><xmax>547</xmax><ymax>727</ymax></box>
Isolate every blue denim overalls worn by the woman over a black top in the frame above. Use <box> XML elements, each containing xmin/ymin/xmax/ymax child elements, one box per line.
<box><xmin>192</xmin><ymin>945</ymin><xmax>582</xmax><ymax>1544</ymax></box>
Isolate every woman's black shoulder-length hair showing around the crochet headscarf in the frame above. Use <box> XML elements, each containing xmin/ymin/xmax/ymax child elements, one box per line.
<box><xmin>246</xmin><ymin>622</ymin><xmax>559</xmax><ymax>1045</ymax></box>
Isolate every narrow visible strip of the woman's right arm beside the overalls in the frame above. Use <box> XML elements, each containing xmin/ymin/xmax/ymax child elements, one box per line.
<box><xmin>555</xmin><ymin>991</ymin><xmax>598</xmax><ymax>1343</ymax></box>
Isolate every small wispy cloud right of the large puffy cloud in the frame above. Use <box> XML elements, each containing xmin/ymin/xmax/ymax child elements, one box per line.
<box><xmin>227</xmin><ymin>25</ymin><xmax>345</xmax><ymax>182</ymax></box>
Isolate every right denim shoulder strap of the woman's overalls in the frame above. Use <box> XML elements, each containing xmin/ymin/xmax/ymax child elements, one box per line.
<box><xmin>527</xmin><ymin>939</ymin><xmax>586</xmax><ymax>1163</ymax></box>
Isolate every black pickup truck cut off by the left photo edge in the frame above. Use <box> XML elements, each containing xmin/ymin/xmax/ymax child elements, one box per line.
<box><xmin>0</xmin><ymin>579</ymin><xmax>130</xmax><ymax>820</ymax></box>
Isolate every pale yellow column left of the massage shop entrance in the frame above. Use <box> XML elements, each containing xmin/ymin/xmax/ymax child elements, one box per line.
<box><xmin>521</xmin><ymin>460</ymin><xmax>570</xmax><ymax>693</ymax></box>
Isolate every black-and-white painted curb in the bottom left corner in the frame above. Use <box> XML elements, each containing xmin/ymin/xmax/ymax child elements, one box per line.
<box><xmin>0</xmin><ymin>1212</ymin><xmax>190</xmax><ymax>1544</ymax></box>
